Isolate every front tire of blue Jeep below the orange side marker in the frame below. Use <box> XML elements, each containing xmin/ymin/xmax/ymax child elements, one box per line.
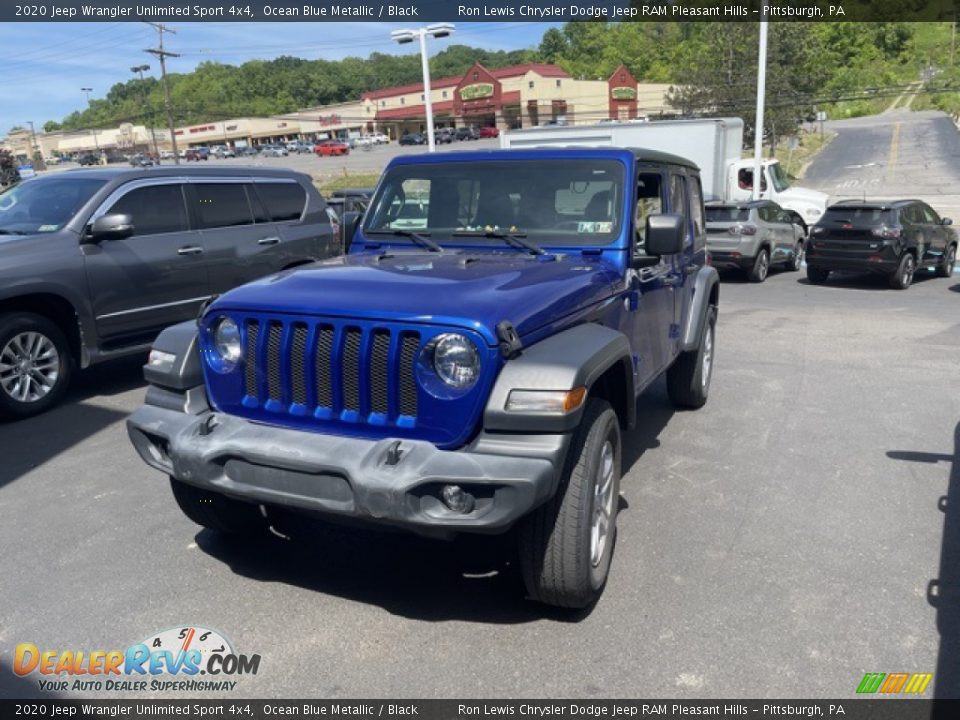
<box><xmin>518</xmin><ymin>398</ymin><xmax>621</xmax><ymax>608</ymax></box>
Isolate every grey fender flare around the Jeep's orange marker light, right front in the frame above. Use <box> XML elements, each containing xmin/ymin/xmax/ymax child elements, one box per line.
<box><xmin>483</xmin><ymin>323</ymin><xmax>636</xmax><ymax>433</ymax></box>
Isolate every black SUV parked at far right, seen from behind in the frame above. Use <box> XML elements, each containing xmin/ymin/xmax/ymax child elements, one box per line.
<box><xmin>807</xmin><ymin>200</ymin><xmax>957</xmax><ymax>290</ymax></box>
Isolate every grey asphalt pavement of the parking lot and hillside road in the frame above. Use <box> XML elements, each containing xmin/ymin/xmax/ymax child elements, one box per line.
<box><xmin>0</xmin><ymin>111</ymin><xmax>960</xmax><ymax>698</ymax></box>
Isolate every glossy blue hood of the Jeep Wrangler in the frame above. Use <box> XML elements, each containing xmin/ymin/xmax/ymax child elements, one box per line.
<box><xmin>208</xmin><ymin>250</ymin><xmax>618</xmax><ymax>345</ymax></box>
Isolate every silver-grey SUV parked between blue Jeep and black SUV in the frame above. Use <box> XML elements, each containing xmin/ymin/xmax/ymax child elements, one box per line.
<box><xmin>706</xmin><ymin>200</ymin><xmax>805</xmax><ymax>282</ymax></box>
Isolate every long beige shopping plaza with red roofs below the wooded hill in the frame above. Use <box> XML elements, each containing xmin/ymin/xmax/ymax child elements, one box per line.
<box><xmin>0</xmin><ymin>63</ymin><xmax>670</xmax><ymax>157</ymax></box>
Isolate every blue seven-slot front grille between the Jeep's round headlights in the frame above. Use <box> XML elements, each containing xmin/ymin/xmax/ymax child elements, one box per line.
<box><xmin>243</xmin><ymin>319</ymin><xmax>420</xmax><ymax>424</ymax></box>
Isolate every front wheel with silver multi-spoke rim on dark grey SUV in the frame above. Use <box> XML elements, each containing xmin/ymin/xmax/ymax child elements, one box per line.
<box><xmin>0</xmin><ymin>313</ymin><xmax>73</xmax><ymax>420</ymax></box>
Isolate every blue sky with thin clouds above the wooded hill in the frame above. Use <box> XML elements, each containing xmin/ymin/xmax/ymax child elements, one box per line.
<box><xmin>0</xmin><ymin>22</ymin><xmax>559</xmax><ymax>137</ymax></box>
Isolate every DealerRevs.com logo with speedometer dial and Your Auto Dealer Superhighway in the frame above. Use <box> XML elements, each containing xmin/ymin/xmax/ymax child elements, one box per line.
<box><xmin>13</xmin><ymin>626</ymin><xmax>260</xmax><ymax>692</ymax></box>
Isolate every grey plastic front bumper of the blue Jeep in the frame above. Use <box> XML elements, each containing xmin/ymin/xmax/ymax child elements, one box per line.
<box><xmin>127</xmin><ymin>404</ymin><xmax>570</xmax><ymax>535</ymax></box>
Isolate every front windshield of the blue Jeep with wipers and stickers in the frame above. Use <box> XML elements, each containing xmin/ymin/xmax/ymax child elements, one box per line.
<box><xmin>363</xmin><ymin>159</ymin><xmax>624</xmax><ymax>246</ymax></box>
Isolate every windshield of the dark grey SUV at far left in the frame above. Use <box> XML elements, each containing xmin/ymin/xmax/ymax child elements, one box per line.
<box><xmin>0</xmin><ymin>176</ymin><xmax>106</xmax><ymax>235</ymax></box>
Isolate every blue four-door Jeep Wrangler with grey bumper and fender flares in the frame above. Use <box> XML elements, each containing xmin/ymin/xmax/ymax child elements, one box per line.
<box><xmin>128</xmin><ymin>148</ymin><xmax>718</xmax><ymax>607</ymax></box>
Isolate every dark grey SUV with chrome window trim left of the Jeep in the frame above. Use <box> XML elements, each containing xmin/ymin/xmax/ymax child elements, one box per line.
<box><xmin>0</xmin><ymin>166</ymin><xmax>340</xmax><ymax>418</ymax></box>
